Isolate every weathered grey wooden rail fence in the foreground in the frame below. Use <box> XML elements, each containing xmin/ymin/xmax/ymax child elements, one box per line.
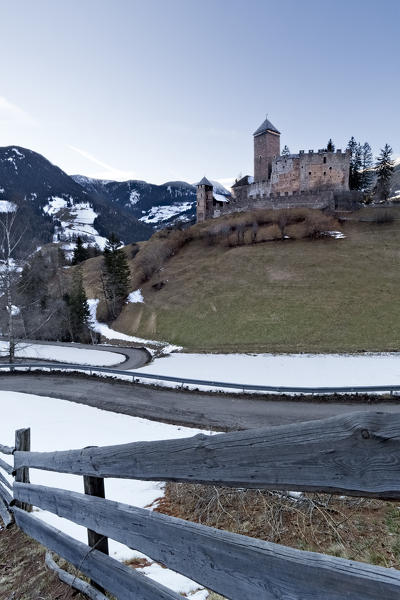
<box><xmin>0</xmin><ymin>412</ymin><xmax>400</xmax><ymax>600</ymax></box>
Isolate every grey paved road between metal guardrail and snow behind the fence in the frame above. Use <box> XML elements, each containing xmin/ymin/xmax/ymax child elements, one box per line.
<box><xmin>0</xmin><ymin>373</ymin><xmax>400</xmax><ymax>430</ymax></box>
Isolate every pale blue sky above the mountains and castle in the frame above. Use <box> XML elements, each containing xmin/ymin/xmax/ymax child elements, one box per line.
<box><xmin>0</xmin><ymin>0</ymin><xmax>400</xmax><ymax>183</ymax></box>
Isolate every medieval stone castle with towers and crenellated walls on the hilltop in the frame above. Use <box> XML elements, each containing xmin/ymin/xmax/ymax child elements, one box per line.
<box><xmin>197</xmin><ymin>119</ymin><xmax>360</xmax><ymax>222</ymax></box>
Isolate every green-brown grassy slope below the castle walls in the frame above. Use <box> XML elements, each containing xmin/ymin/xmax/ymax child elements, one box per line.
<box><xmin>81</xmin><ymin>209</ymin><xmax>400</xmax><ymax>352</ymax></box>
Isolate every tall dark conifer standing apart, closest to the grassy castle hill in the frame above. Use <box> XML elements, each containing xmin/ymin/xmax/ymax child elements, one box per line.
<box><xmin>102</xmin><ymin>233</ymin><xmax>130</xmax><ymax>319</ymax></box>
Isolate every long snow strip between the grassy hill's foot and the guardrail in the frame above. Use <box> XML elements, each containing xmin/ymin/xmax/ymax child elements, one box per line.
<box><xmin>133</xmin><ymin>353</ymin><xmax>400</xmax><ymax>391</ymax></box>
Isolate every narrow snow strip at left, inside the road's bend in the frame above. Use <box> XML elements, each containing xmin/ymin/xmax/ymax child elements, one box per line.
<box><xmin>0</xmin><ymin>341</ymin><xmax>125</xmax><ymax>367</ymax></box>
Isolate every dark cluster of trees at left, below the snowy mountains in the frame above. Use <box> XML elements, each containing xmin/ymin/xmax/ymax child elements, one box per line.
<box><xmin>0</xmin><ymin>217</ymin><xmax>130</xmax><ymax>362</ymax></box>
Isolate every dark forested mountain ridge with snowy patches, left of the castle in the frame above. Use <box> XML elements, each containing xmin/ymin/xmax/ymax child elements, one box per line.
<box><xmin>0</xmin><ymin>145</ymin><xmax>225</xmax><ymax>252</ymax></box>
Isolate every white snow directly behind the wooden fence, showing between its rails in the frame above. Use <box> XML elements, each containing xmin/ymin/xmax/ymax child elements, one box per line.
<box><xmin>0</xmin><ymin>392</ymin><xmax>208</xmax><ymax>598</ymax></box>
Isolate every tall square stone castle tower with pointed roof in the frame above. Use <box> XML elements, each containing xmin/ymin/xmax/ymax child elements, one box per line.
<box><xmin>253</xmin><ymin>119</ymin><xmax>281</xmax><ymax>182</ymax></box>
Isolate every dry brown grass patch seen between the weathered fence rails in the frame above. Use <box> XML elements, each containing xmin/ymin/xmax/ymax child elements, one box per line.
<box><xmin>159</xmin><ymin>483</ymin><xmax>400</xmax><ymax>568</ymax></box>
